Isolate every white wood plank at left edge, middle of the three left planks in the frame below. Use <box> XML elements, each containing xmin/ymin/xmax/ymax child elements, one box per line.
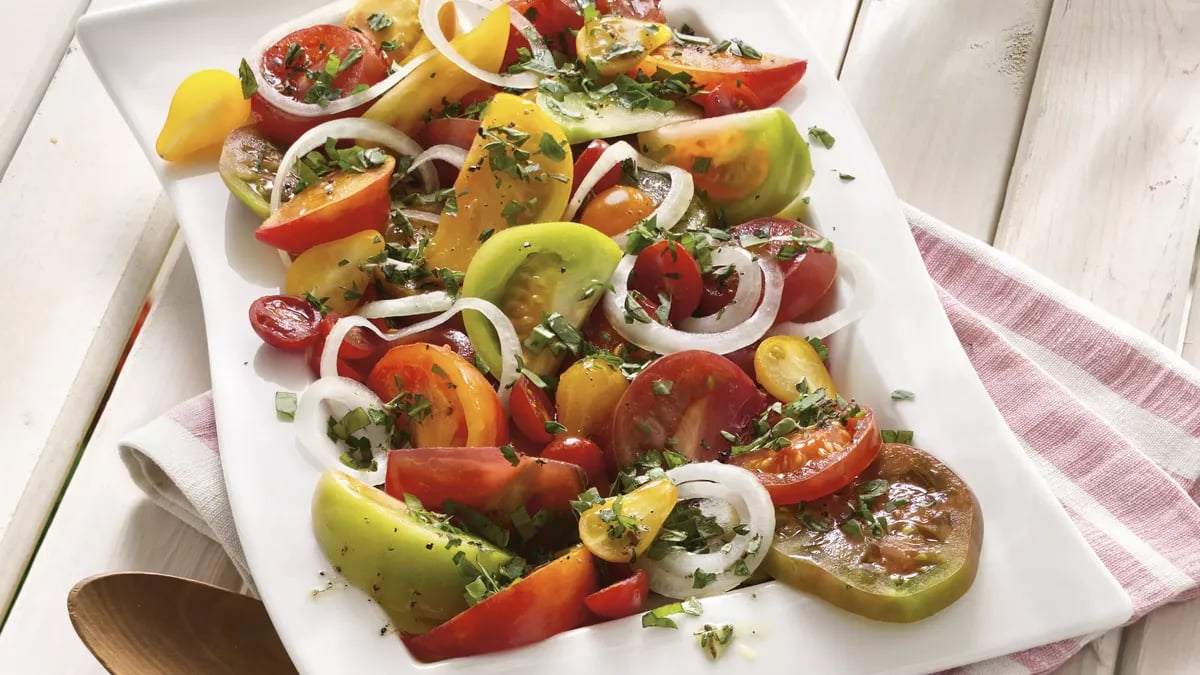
<box><xmin>0</xmin><ymin>42</ymin><xmax>175</xmax><ymax>615</ymax></box>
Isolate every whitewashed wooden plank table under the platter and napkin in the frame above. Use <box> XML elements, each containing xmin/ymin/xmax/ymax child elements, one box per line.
<box><xmin>0</xmin><ymin>0</ymin><xmax>1200</xmax><ymax>675</ymax></box>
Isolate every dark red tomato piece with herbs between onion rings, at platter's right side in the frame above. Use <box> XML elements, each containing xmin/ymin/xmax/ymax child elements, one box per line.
<box><xmin>730</xmin><ymin>217</ymin><xmax>838</xmax><ymax>324</ymax></box>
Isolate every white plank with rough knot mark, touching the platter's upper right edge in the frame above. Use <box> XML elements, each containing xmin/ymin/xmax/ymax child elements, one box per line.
<box><xmin>829</xmin><ymin>0</ymin><xmax>1050</xmax><ymax>241</ymax></box>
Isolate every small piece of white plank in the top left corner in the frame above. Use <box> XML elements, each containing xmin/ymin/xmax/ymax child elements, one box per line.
<box><xmin>0</xmin><ymin>0</ymin><xmax>88</xmax><ymax>174</ymax></box>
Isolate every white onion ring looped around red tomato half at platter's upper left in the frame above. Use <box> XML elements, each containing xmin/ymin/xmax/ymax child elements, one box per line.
<box><xmin>246</xmin><ymin>1</ymin><xmax>440</xmax><ymax>118</ymax></box>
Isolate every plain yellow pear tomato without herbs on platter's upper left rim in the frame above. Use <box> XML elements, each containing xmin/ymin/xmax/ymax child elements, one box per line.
<box><xmin>155</xmin><ymin>70</ymin><xmax>250</xmax><ymax>162</ymax></box>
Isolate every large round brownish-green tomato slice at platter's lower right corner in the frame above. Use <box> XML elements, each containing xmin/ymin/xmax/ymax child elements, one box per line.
<box><xmin>763</xmin><ymin>443</ymin><xmax>984</xmax><ymax>621</ymax></box>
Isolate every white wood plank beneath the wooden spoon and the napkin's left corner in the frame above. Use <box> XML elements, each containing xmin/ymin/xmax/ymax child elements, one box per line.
<box><xmin>0</xmin><ymin>249</ymin><xmax>240</xmax><ymax>675</ymax></box>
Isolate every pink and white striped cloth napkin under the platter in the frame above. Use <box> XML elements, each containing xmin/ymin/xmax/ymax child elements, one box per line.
<box><xmin>120</xmin><ymin>209</ymin><xmax>1200</xmax><ymax>675</ymax></box>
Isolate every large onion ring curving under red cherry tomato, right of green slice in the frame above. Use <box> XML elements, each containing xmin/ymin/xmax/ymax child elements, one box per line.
<box><xmin>602</xmin><ymin>256</ymin><xmax>784</xmax><ymax>354</ymax></box>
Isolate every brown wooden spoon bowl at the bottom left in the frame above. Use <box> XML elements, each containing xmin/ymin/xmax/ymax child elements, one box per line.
<box><xmin>67</xmin><ymin>572</ymin><xmax>296</xmax><ymax>675</ymax></box>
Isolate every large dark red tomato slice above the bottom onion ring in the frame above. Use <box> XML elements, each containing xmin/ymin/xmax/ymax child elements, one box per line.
<box><xmin>612</xmin><ymin>350</ymin><xmax>767</xmax><ymax>467</ymax></box>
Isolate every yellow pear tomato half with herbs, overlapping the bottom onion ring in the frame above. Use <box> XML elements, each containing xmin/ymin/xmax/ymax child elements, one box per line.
<box><xmin>580</xmin><ymin>478</ymin><xmax>679</xmax><ymax>562</ymax></box>
